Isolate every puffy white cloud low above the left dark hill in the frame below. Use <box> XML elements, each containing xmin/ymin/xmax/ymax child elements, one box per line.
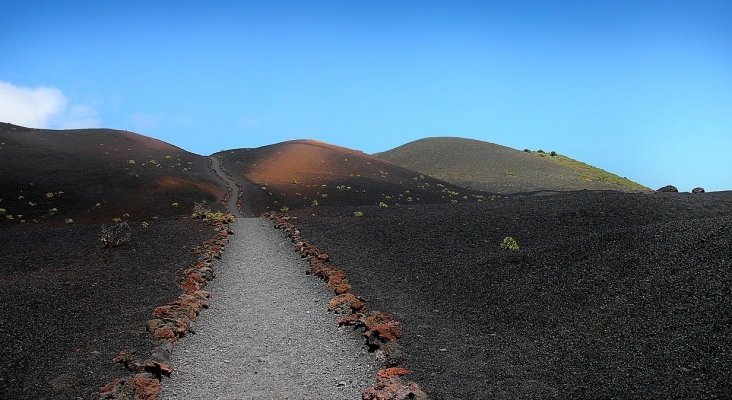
<box><xmin>0</xmin><ymin>81</ymin><xmax>100</xmax><ymax>129</ymax></box>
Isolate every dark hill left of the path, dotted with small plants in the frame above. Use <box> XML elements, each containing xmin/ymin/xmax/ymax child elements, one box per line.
<box><xmin>0</xmin><ymin>123</ymin><xmax>223</xmax><ymax>224</ymax></box>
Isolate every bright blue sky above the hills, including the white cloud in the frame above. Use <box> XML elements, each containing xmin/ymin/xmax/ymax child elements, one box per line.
<box><xmin>0</xmin><ymin>0</ymin><xmax>732</xmax><ymax>191</ymax></box>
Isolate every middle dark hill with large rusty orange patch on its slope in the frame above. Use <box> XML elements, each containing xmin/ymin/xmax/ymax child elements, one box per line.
<box><xmin>215</xmin><ymin>140</ymin><xmax>485</xmax><ymax>213</ymax></box>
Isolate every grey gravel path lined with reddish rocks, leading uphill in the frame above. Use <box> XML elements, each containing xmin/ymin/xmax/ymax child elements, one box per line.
<box><xmin>162</xmin><ymin>158</ymin><xmax>376</xmax><ymax>399</ymax></box>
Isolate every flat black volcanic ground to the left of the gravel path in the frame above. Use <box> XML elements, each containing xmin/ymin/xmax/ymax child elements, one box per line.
<box><xmin>0</xmin><ymin>219</ymin><xmax>215</xmax><ymax>399</ymax></box>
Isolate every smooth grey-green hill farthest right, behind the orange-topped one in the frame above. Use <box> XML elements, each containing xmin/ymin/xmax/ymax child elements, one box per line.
<box><xmin>376</xmin><ymin>137</ymin><xmax>648</xmax><ymax>193</ymax></box>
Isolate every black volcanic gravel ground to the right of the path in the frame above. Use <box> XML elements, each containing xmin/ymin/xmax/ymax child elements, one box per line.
<box><xmin>294</xmin><ymin>192</ymin><xmax>732</xmax><ymax>399</ymax></box>
